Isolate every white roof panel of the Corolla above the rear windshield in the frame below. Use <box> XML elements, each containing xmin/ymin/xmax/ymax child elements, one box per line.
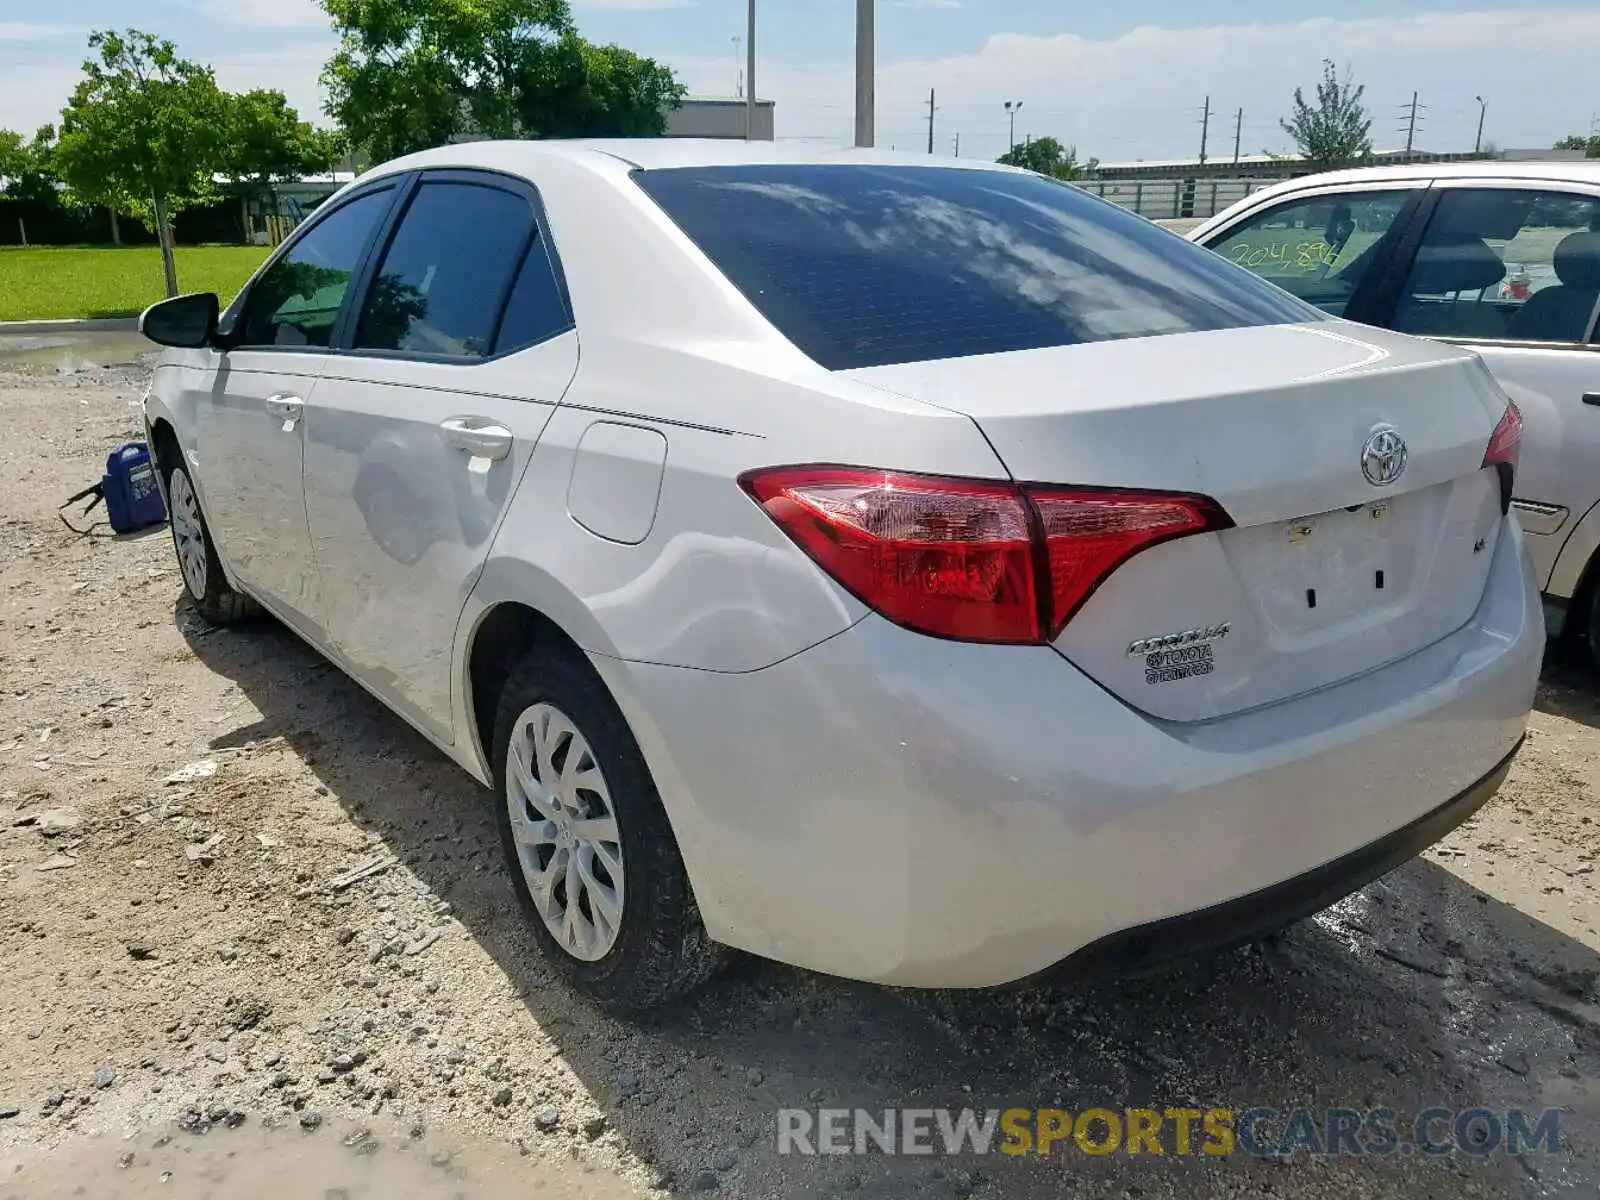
<box><xmin>363</xmin><ymin>138</ymin><xmax>1016</xmax><ymax>178</ymax></box>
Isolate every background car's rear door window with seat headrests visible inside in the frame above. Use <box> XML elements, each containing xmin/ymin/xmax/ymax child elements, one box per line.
<box><xmin>1392</xmin><ymin>187</ymin><xmax>1600</xmax><ymax>342</ymax></box>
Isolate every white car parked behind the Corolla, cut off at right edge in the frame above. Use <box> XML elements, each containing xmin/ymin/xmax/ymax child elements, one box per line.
<box><xmin>1189</xmin><ymin>162</ymin><xmax>1600</xmax><ymax>667</ymax></box>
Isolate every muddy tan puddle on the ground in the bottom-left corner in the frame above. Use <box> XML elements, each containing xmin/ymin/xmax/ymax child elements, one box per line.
<box><xmin>0</xmin><ymin>1117</ymin><xmax>642</xmax><ymax>1200</ymax></box>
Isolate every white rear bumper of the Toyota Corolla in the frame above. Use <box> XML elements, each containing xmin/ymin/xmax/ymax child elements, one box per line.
<box><xmin>597</xmin><ymin>522</ymin><xmax>1544</xmax><ymax>987</ymax></box>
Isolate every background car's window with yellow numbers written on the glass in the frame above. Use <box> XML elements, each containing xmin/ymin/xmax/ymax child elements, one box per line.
<box><xmin>1210</xmin><ymin>190</ymin><xmax>1413</xmax><ymax>317</ymax></box>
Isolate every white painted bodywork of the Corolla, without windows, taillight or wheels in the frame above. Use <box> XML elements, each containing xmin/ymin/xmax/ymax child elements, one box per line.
<box><xmin>146</xmin><ymin>141</ymin><xmax>1544</xmax><ymax>986</ymax></box>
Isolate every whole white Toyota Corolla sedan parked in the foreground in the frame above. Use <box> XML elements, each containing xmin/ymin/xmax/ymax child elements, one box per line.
<box><xmin>142</xmin><ymin>141</ymin><xmax>1544</xmax><ymax>1008</ymax></box>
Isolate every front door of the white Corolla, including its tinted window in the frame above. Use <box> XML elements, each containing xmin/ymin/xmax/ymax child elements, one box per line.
<box><xmin>189</xmin><ymin>187</ymin><xmax>394</xmax><ymax>640</ymax></box>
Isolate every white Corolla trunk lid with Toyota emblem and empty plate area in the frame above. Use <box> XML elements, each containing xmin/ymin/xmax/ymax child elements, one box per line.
<box><xmin>846</xmin><ymin>322</ymin><xmax>1506</xmax><ymax>722</ymax></box>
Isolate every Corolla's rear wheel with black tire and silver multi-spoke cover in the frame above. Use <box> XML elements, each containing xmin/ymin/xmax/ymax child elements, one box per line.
<box><xmin>493</xmin><ymin>650</ymin><xmax>731</xmax><ymax>1011</ymax></box>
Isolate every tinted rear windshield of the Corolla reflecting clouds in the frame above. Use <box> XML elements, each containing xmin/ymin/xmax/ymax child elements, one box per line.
<box><xmin>634</xmin><ymin>165</ymin><xmax>1325</xmax><ymax>370</ymax></box>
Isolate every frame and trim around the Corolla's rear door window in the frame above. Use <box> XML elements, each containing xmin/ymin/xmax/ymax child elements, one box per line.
<box><xmin>328</xmin><ymin>166</ymin><xmax>578</xmax><ymax>366</ymax></box>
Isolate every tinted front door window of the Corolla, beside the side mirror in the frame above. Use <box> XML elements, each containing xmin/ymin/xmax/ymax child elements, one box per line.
<box><xmin>237</xmin><ymin>187</ymin><xmax>394</xmax><ymax>346</ymax></box>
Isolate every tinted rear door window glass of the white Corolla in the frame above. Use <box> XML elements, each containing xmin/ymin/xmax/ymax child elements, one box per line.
<box><xmin>354</xmin><ymin>182</ymin><xmax>533</xmax><ymax>358</ymax></box>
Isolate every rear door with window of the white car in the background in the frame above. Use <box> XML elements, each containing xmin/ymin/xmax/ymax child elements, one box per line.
<box><xmin>1389</xmin><ymin>181</ymin><xmax>1600</xmax><ymax>597</ymax></box>
